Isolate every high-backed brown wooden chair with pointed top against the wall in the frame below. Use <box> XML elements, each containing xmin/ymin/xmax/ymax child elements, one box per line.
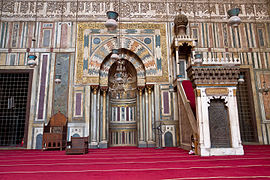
<box><xmin>42</xmin><ymin>112</ymin><xmax>68</xmax><ymax>151</ymax></box>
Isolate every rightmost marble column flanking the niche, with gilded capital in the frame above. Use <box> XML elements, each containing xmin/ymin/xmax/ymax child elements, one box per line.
<box><xmin>147</xmin><ymin>85</ymin><xmax>155</xmax><ymax>147</ymax></box>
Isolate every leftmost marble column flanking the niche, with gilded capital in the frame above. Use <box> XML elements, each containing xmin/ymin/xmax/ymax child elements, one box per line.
<box><xmin>90</xmin><ymin>86</ymin><xmax>98</xmax><ymax>148</ymax></box>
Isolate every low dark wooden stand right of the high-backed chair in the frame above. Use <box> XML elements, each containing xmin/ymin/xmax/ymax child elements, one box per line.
<box><xmin>66</xmin><ymin>137</ymin><xmax>88</xmax><ymax>154</ymax></box>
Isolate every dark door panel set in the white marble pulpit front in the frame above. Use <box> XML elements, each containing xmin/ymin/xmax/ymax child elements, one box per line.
<box><xmin>208</xmin><ymin>99</ymin><xmax>231</xmax><ymax>148</ymax></box>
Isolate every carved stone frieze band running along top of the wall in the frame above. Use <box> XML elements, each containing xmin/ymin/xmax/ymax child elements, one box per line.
<box><xmin>1</xmin><ymin>0</ymin><xmax>270</xmax><ymax>22</ymax></box>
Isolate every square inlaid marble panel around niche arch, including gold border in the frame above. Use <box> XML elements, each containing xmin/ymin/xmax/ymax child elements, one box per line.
<box><xmin>75</xmin><ymin>23</ymin><xmax>168</xmax><ymax>84</ymax></box>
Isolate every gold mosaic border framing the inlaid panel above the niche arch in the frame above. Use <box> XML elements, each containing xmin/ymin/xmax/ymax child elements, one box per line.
<box><xmin>75</xmin><ymin>23</ymin><xmax>169</xmax><ymax>84</ymax></box>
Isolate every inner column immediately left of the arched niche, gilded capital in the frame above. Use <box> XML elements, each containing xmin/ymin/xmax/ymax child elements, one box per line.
<box><xmin>100</xmin><ymin>87</ymin><xmax>108</xmax><ymax>148</ymax></box>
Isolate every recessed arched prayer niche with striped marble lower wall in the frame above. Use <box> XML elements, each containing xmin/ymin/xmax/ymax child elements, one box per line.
<box><xmin>108</xmin><ymin>58</ymin><xmax>137</xmax><ymax>146</ymax></box>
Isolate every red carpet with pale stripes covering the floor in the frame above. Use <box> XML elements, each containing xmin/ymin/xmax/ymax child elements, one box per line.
<box><xmin>0</xmin><ymin>145</ymin><xmax>270</xmax><ymax>180</ymax></box>
